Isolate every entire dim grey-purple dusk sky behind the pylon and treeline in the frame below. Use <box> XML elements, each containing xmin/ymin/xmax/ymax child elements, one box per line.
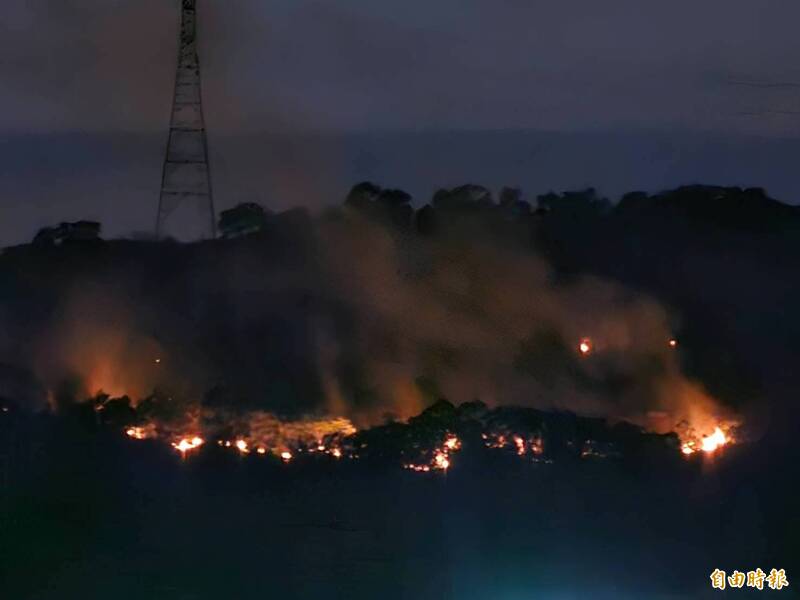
<box><xmin>0</xmin><ymin>0</ymin><xmax>800</xmax><ymax>245</ymax></box>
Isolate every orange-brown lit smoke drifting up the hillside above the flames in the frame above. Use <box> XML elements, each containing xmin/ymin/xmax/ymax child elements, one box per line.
<box><xmin>0</xmin><ymin>197</ymin><xmax>736</xmax><ymax>440</ymax></box>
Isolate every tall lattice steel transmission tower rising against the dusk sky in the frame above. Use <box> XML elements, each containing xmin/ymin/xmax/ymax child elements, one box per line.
<box><xmin>156</xmin><ymin>0</ymin><xmax>216</xmax><ymax>238</ymax></box>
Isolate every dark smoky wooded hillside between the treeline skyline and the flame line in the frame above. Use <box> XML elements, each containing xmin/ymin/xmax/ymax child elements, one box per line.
<box><xmin>0</xmin><ymin>184</ymin><xmax>800</xmax><ymax>442</ymax></box>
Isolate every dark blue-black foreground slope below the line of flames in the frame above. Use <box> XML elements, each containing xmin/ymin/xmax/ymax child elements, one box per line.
<box><xmin>0</xmin><ymin>417</ymin><xmax>797</xmax><ymax>600</ymax></box>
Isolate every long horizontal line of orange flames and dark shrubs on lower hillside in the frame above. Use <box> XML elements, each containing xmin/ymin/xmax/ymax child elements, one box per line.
<box><xmin>111</xmin><ymin>394</ymin><xmax>737</xmax><ymax>473</ymax></box>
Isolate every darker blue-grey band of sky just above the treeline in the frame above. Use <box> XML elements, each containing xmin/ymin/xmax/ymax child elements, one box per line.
<box><xmin>0</xmin><ymin>131</ymin><xmax>800</xmax><ymax>246</ymax></box>
